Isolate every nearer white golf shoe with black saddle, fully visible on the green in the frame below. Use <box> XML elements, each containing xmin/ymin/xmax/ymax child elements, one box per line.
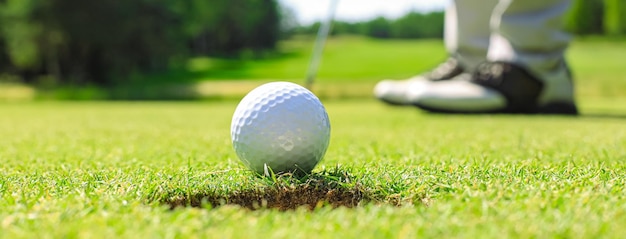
<box><xmin>408</xmin><ymin>62</ymin><xmax>578</xmax><ymax>115</ymax></box>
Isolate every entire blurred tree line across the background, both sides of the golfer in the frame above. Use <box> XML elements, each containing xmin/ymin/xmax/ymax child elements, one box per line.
<box><xmin>0</xmin><ymin>0</ymin><xmax>626</xmax><ymax>88</ymax></box>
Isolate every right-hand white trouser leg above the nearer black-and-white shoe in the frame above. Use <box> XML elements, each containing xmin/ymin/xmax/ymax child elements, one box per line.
<box><xmin>487</xmin><ymin>0</ymin><xmax>573</xmax><ymax>103</ymax></box>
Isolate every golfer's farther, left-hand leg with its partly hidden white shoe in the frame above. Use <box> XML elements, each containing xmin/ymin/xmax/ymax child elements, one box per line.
<box><xmin>374</xmin><ymin>0</ymin><xmax>498</xmax><ymax>105</ymax></box>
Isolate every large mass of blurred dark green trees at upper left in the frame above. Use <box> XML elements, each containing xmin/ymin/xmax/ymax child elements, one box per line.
<box><xmin>0</xmin><ymin>0</ymin><xmax>280</xmax><ymax>85</ymax></box>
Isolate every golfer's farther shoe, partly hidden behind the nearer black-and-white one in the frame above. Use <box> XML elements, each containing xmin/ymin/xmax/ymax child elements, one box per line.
<box><xmin>374</xmin><ymin>57</ymin><xmax>464</xmax><ymax>105</ymax></box>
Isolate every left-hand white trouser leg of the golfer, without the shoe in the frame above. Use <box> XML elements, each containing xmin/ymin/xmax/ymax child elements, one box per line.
<box><xmin>444</xmin><ymin>0</ymin><xmax>498</xmax><ymax>71</ymax></box>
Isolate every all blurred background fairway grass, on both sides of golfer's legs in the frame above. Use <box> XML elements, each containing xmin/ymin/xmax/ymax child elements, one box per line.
<box><xmin>121</xmin><ymin>36</ymin><xmax>626</xmax><ymax>98</ymax></box>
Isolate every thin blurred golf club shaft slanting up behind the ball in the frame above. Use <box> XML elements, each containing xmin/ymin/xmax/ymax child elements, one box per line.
<box><xmin>304</xmin><ymin>0</ymin><xmax>339</xmax><ymax>90</ymax></box>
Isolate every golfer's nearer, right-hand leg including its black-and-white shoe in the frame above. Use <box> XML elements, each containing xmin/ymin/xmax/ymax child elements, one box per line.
<box><xmin>413</xmin><ymin>0</ymin><xmax>577</xmax><ymax>114</ymax></box>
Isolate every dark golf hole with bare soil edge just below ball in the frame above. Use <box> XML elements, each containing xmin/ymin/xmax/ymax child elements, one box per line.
<box><xmin>161</xmin><ymin>170</ymin><xmax>398</xmax><ymax>211</ymax></box>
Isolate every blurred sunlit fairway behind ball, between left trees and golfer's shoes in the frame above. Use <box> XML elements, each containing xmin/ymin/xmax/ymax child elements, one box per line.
<box><xmin>96</xmin><ymin>36</ymin><xmax>446</xmax><ymax>100</ymax></box>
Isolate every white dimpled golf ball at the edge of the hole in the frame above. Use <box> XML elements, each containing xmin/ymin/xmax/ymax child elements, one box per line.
<box><xmin>230</xmin><ymin>82</ymin><xmax>330</xmax><ymax>174</ymax></box>
